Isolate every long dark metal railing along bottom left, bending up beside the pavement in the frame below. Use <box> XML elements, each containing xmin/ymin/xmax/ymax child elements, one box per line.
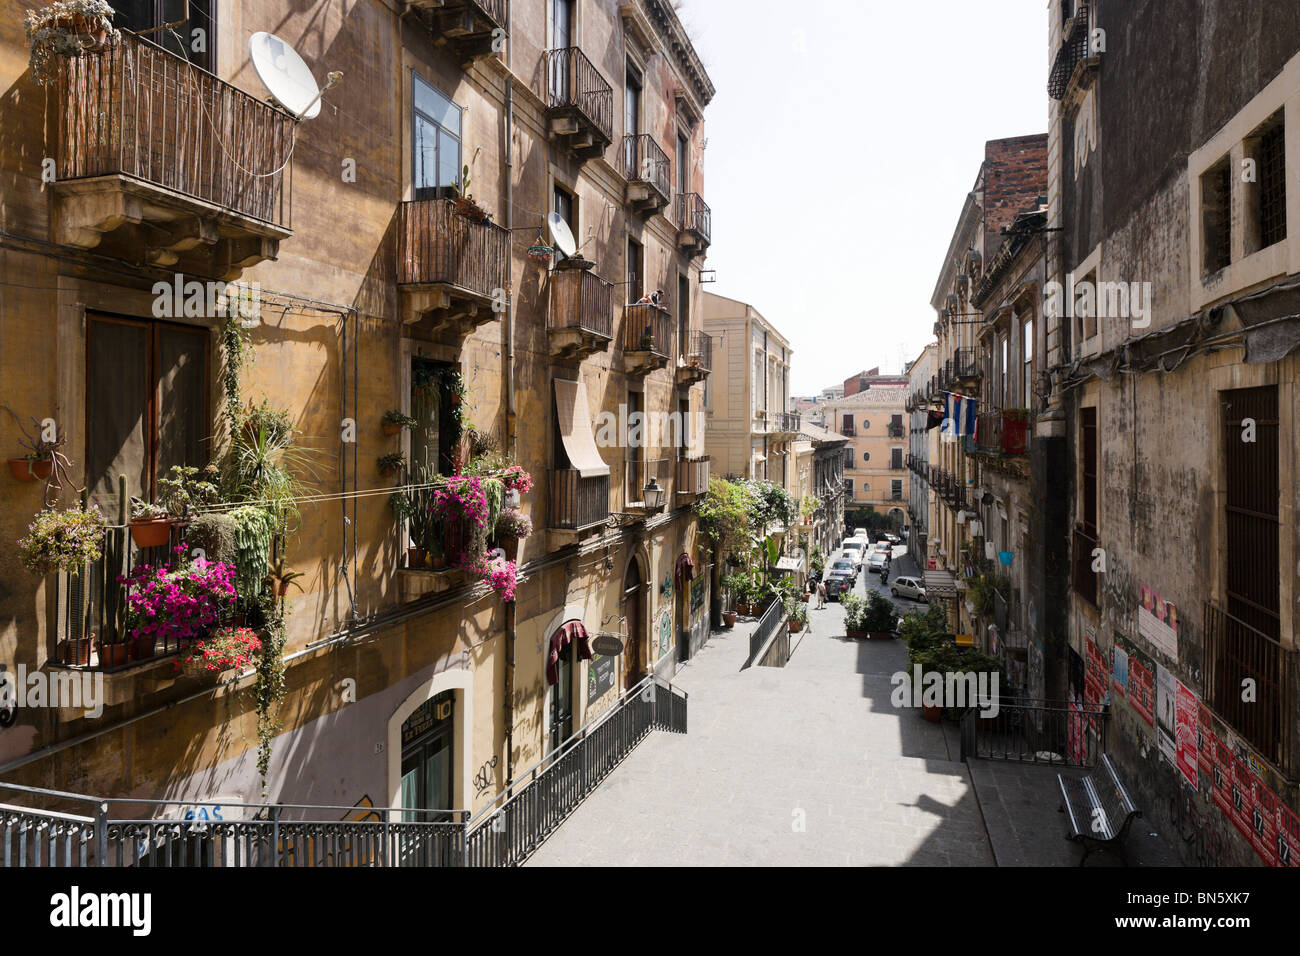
<box><xmin>0</xmin><ymin>676</ymin><xmax>688</xmax><ymax>868</ymax></box>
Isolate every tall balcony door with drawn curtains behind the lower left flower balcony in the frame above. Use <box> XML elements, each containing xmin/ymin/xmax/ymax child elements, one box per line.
<box><xmin>86</xmin><ymin>315</ymin><xmax>212</xmax><ymax>522</ymax></box>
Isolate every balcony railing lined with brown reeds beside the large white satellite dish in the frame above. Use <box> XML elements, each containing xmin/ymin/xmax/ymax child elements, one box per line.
<box><xmin>57</xmin><ymin>31</ymin><xmax>295</xmax><ymax>229</ymax></box>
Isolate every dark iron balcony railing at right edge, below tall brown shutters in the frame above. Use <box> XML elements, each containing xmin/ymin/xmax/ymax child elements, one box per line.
<box><xmin>1204</xmin><ymin>602</ymin><xmax>1300</xmax><ymax>779</ymax></box>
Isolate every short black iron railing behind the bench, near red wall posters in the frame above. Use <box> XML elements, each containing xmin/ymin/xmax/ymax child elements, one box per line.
<box><xmin>961</xmin><ymin>697</ymin><xmax>1109</xmax><ymax>767</ymax></box>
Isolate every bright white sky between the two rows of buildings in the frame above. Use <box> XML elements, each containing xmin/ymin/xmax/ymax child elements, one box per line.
<box><xmin>680</xmin><ymin>0</ymin><xmax>1049</xmax><ymax>395</ymax></box>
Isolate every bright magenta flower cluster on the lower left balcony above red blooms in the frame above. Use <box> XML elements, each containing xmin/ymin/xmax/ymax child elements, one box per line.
<box><xmin>126</xmin><ymin>546</ymin><xmax>235</xmax><ymax>655</ymax></box>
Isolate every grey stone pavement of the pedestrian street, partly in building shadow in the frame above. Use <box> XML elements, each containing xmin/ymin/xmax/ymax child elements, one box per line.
<box><xmin>529</xmin><ymin>549</ymin><xmax>995</xmax><ymax>866</ymax></box>
